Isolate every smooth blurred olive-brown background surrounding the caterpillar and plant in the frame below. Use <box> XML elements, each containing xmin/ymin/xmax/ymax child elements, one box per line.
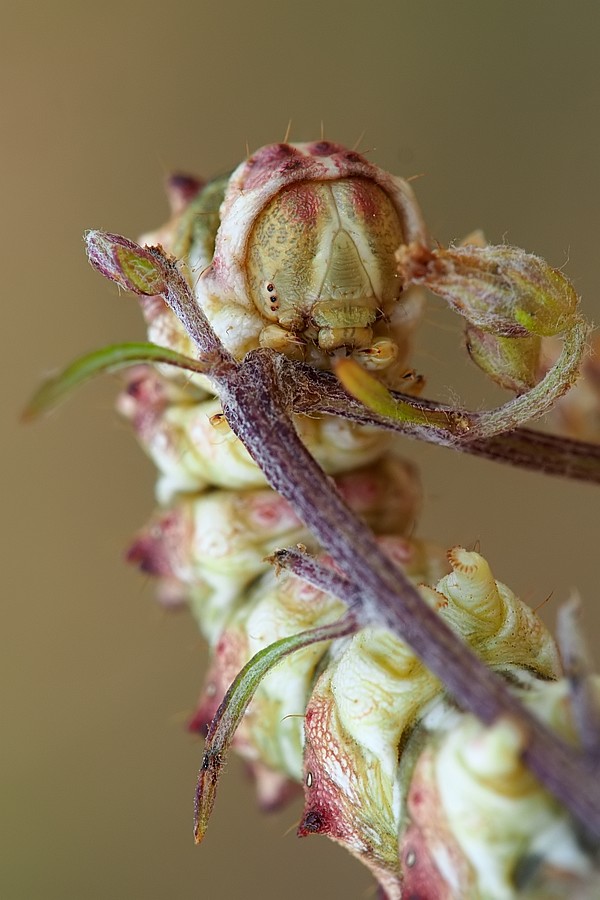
<box><xmin>0</xmin><ymin>0</ymin><xmax>600</xmax><ymax>900</ymax></box>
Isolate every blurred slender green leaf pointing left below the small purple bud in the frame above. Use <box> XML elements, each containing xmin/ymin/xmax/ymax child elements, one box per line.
<box><xmin>23</xmin><ymin>343</ymin><xmax>208</xmax><ymax>422</ymax></box>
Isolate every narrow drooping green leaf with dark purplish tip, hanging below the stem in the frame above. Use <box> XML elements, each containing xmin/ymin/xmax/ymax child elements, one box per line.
<box><xmin>194</xmin><ymin>613</ymin><xmax>358</xmax><ymax>844</ymax></box>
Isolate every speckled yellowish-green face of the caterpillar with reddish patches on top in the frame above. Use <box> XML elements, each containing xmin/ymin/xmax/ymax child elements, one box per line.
<box><xmin>246</xmin><ymin>177</ymin><xmax>403</xmax><ymax>350</ymax></box>
